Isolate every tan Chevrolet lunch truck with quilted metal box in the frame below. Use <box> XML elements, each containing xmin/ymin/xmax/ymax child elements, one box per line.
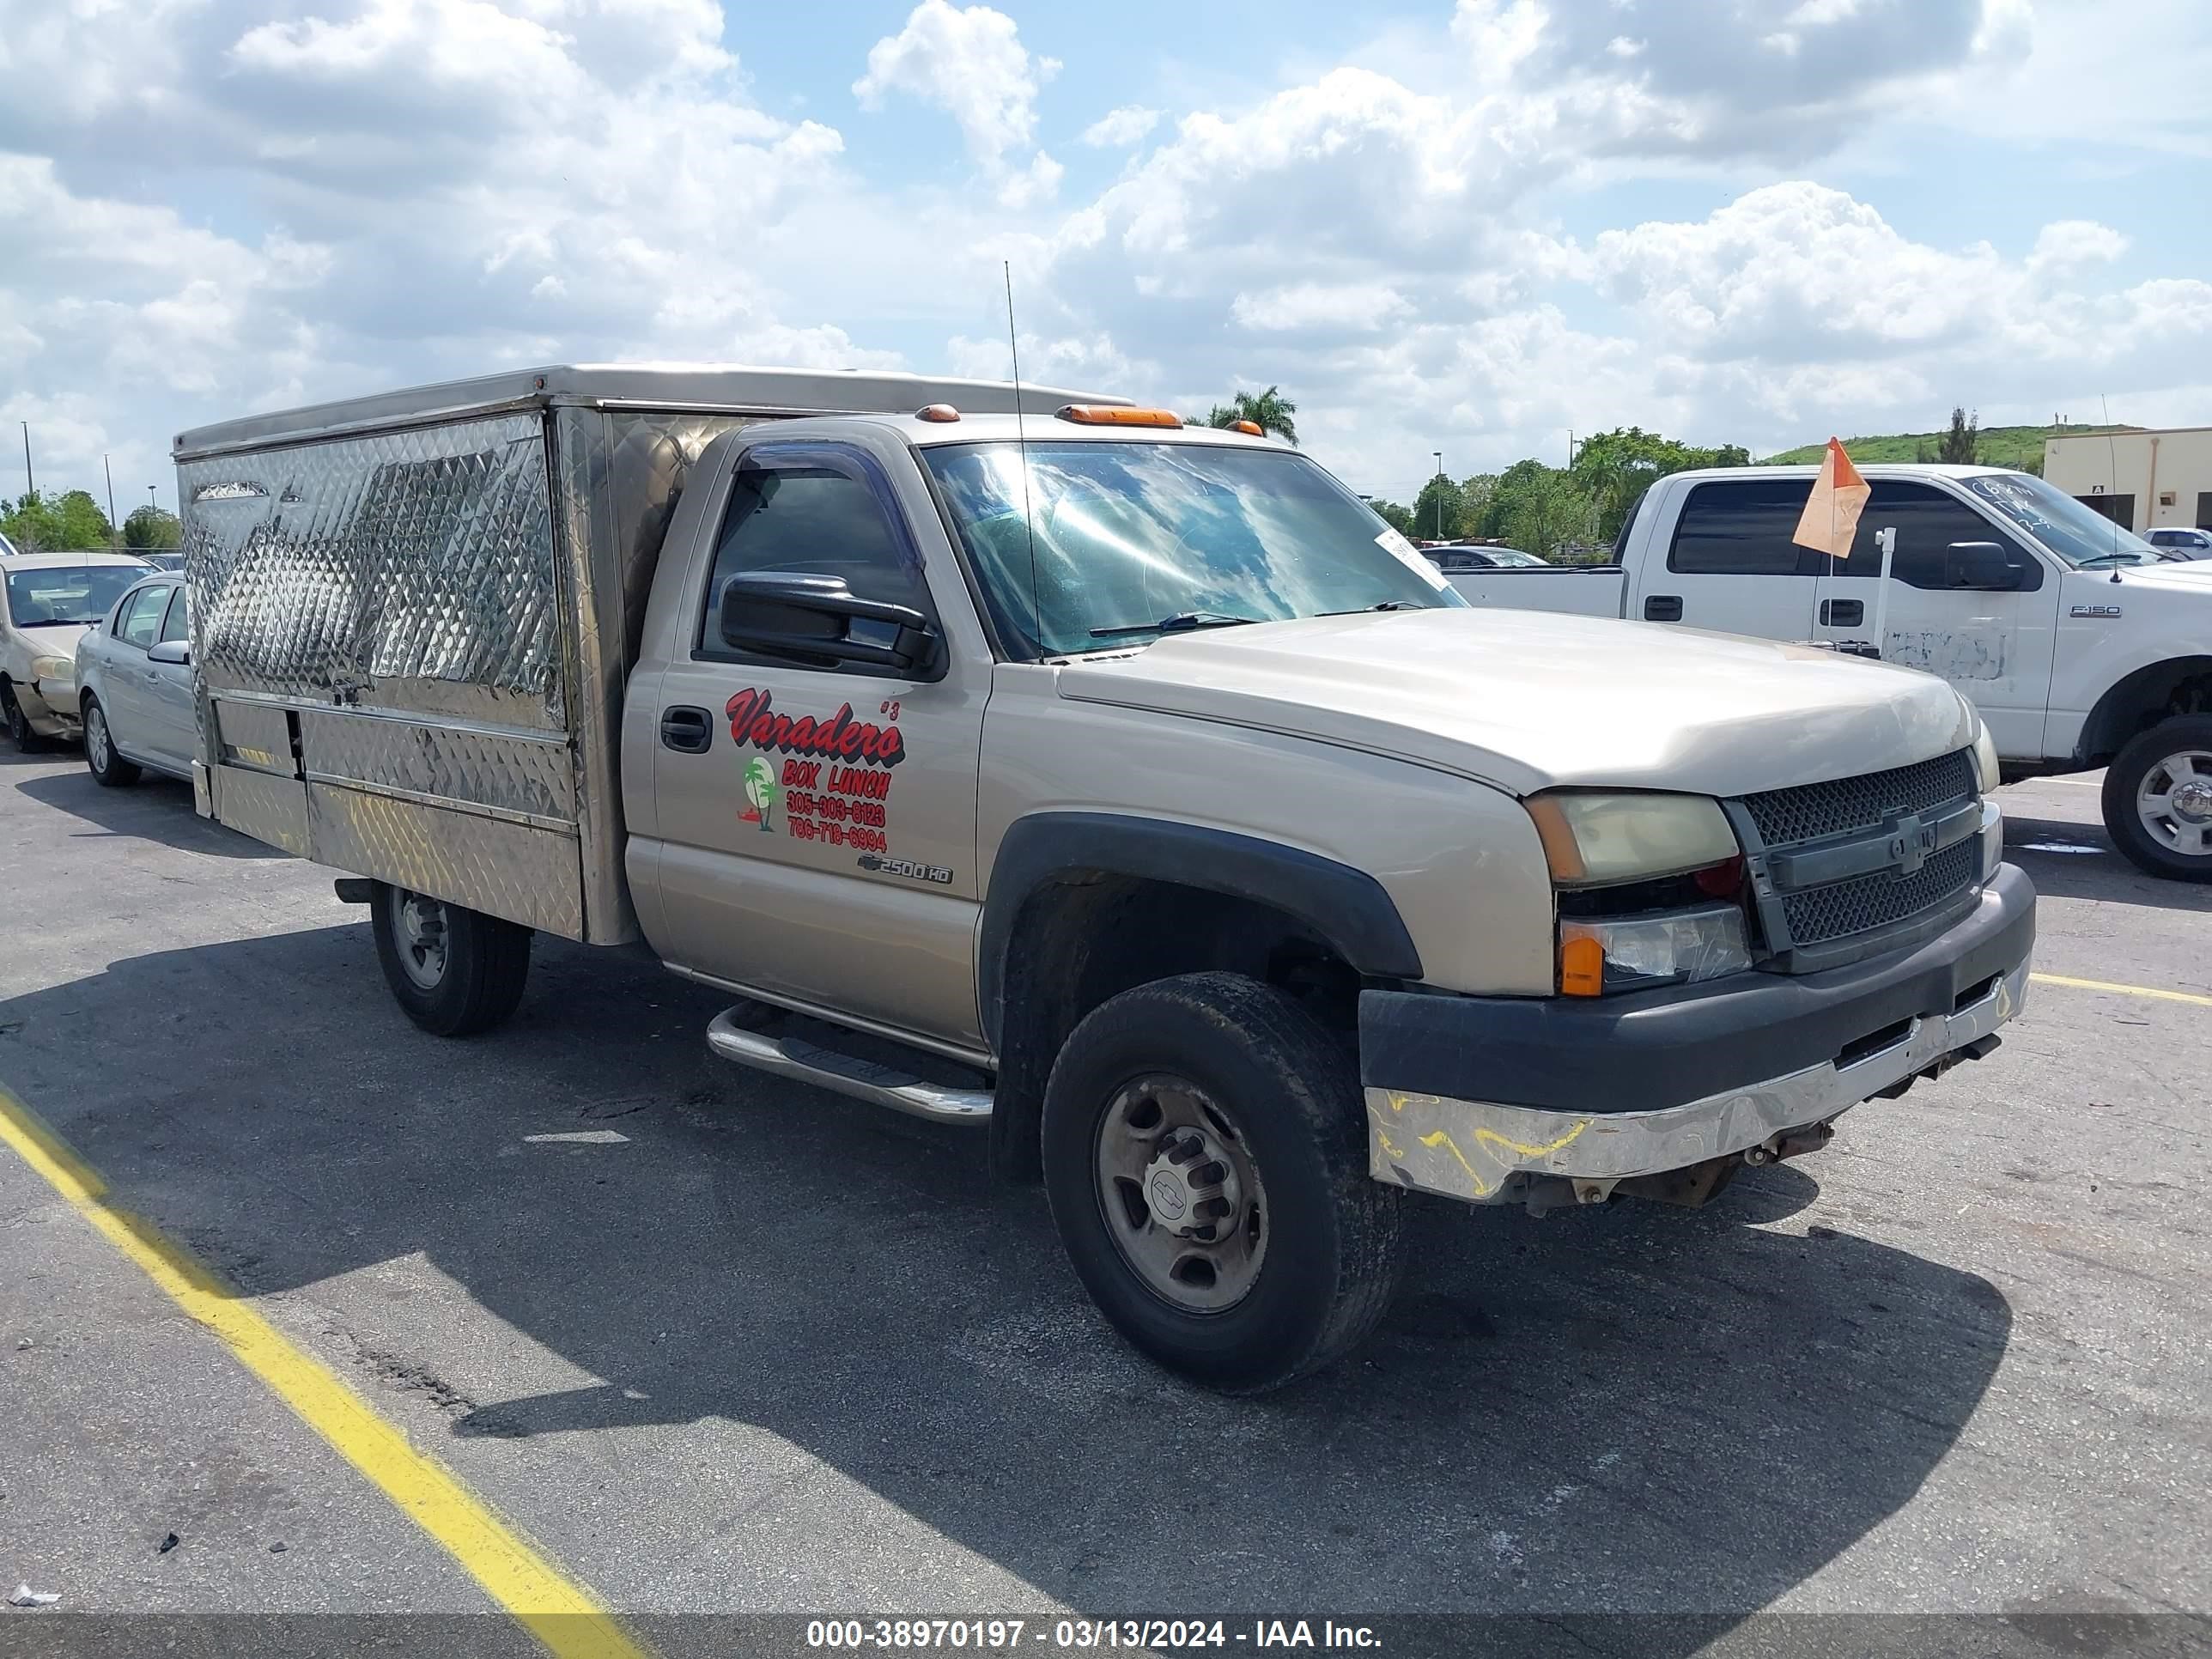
<box><xmin>177</xmin><ymin>369</ymin><xmax>2035</xmax><ymax>1391</ymax></box>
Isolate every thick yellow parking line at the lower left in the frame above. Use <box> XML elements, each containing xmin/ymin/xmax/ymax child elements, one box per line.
<box><xmin>0</xmin><ymin>1088</ymin><xmax>646</xmax><ymax>1659</ymax></box>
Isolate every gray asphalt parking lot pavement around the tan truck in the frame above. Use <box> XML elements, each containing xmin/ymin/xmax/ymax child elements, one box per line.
<box><xmin>0</xmin><ymin>752</ymin><xmax>2212</xmax><ymax>1652</ymax></box>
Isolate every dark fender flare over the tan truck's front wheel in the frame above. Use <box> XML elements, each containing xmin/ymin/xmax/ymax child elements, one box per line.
<box><xmin>975</xmin><ymin>811</ymin><xmax>1422</xmax><ymax>1048</ymax></box>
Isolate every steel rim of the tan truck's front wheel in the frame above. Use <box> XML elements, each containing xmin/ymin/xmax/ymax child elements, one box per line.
<box><xmin>1093</xmin><ymin>1073</ymin><xmax>1270</xmax><ymax>1314</ymax></box>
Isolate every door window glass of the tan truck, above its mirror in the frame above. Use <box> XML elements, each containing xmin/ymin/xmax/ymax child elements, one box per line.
<box><xmin>695</xmin><ymin>452</ymin><xmax>931</xmax><ymax>672</ymax></box>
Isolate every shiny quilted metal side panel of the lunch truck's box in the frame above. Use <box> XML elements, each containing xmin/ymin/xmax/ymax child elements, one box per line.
<box><xmin>177</xmin><ymin>411</ymin><xmax>597</xmax><ymax>938</ymax></box>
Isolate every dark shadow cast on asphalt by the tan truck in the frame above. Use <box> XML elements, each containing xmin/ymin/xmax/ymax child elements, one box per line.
<box><xmin>0</xmin><ymin>925</ymin><xmax>2011</xmax><ymax>1652</ymax></box>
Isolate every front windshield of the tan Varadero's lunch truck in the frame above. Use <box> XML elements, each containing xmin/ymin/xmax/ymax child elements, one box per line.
<box><xmin>922</xmin><ymin>442</ymin><xmax>1467</xmax><ymax>657</ymax></box>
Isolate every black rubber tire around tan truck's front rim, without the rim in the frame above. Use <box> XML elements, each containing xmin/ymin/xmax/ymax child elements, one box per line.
<box><xmin>1042</xmin><ymin>973</ymin><xmax>1402</xmax><ymax>1394</ymax></box>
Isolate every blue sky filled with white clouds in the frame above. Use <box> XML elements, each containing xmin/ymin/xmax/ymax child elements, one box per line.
<box><xmin>0</xmin><ymin>0</ymin><xmax>2212</xmax><ymax>513</ymax></box>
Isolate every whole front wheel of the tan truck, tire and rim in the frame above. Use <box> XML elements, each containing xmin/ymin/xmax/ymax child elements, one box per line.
<box><xmin>1042</xmin><ymin>973</ymin><xmax>1401</xmax><ymax>1394</ymax></box>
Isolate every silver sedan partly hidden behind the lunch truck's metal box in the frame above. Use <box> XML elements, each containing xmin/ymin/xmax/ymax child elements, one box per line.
<box><xmin>77</xmin><ymin>573</ymin><xmax>199</xmax><ymax>787</ymax></box>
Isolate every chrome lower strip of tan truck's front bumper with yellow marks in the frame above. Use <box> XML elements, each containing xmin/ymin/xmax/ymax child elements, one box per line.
<box><xmin>1367</xmin><ymin>957</ymin><xmax>2028</xmax><ymax>1203</ymax></box>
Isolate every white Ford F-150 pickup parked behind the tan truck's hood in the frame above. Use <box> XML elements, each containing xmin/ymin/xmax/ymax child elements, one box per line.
<box><xmin>1453</xmin><ymin>465</ymin><xmax>2212</xmax><ymax>880</ymax></box>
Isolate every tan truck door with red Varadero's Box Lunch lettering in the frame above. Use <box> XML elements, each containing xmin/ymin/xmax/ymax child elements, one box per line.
<box><xmin>653</xmin><ymin>438</ymin><xmax>991</xmax><ymax>1048</ymax></box>
